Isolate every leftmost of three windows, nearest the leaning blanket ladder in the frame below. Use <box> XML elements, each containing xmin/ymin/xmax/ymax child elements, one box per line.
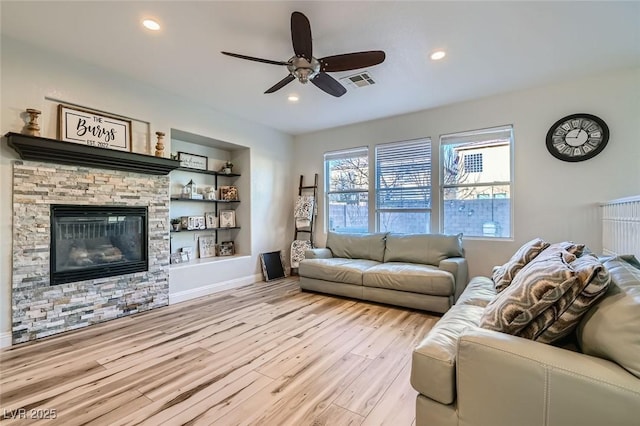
<box><xmin>324</xmin><ymin>148</ymin><xmax>369</xmax><ymax>232</ymax></box>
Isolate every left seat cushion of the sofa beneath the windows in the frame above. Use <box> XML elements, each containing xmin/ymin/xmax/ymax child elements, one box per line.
<box><xmin>298</xmin><ymin>257</ymin><xmax>379</xmax><ymax>285</ymax></box>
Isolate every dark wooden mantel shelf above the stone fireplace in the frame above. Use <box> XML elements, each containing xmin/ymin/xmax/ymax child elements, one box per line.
<box><xmin>5</xmin><ymin>132</ymin><xmax>180</xmax><ymax>175</ymax></box>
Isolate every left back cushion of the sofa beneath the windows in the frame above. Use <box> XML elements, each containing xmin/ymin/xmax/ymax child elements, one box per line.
<box><xmin>326</xmin><ymin>231</ymin><xmax>387</xmax><ymax>262</ymax></box>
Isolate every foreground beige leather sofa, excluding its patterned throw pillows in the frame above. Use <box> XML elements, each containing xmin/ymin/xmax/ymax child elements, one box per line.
<box><xmin>411</xmin><ymin>258</ymin><xmax>640</xmax><ymax>426</ymax></box>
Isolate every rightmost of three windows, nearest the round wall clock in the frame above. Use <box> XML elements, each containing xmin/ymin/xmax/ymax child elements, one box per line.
<box><xmin>440</xmin><ymin>126</ymin><xmax>513</xmax><ymax>238</ymax></box>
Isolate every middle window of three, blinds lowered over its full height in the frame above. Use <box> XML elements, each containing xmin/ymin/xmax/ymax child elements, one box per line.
<box><xmin>376</xmin><ymin>139</ymin><xmax>431</xmax><ymax>233</ymax></box>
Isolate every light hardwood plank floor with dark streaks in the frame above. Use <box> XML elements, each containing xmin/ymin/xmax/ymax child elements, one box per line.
<box><xmin>0</xmin><ymin>278</ymin><xmax>438</xmax><ymax>426</ymax></box>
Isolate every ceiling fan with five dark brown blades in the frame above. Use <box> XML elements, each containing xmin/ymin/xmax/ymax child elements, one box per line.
<box><xmin>221</xmin><ymin>12</ymin><xmax>385</xmax><ymax>97</ymax></box>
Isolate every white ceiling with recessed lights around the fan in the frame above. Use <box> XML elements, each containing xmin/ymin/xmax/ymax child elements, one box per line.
<box><xmin>1</xmin><ymin>0</ymin><xmax>640</xmax><ymax>134</ymax></box>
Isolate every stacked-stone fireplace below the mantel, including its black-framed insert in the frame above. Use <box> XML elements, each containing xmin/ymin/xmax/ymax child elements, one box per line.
<box><xmin>12</xmin><ymin>157</ymin><xmax>169</xmax><ymax>344</ymax></box>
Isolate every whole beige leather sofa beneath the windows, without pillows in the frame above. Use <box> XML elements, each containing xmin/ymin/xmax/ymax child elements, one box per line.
<box><xmin>298</xmin><ymin>232</ymin><xmax>468</xmax><ymax>313</ymax></box>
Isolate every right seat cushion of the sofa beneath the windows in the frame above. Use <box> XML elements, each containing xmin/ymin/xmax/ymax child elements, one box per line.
<box><xmin>362</xmin><ymin>262</ymin><xmax>455</xmax><ymax>296</ymax></box>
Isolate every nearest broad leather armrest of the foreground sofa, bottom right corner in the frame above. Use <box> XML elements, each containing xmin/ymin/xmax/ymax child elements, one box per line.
<box><xmin>456</xmin><ymin>327</ymin><xmax>640</xmax><ymax>426</ymax></box>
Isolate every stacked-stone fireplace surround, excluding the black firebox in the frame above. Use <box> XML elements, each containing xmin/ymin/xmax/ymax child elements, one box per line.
<box><xmin>12</xmin><ymin>161</ymin><xmax>169</xmax><ymax>344</ymax></box>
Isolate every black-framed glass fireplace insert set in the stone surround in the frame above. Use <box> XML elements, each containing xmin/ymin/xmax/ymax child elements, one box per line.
<box><xmin>51</xmin><ymin>205</ymin><xmax>149</xmax><ymax>284</ymax></box>
